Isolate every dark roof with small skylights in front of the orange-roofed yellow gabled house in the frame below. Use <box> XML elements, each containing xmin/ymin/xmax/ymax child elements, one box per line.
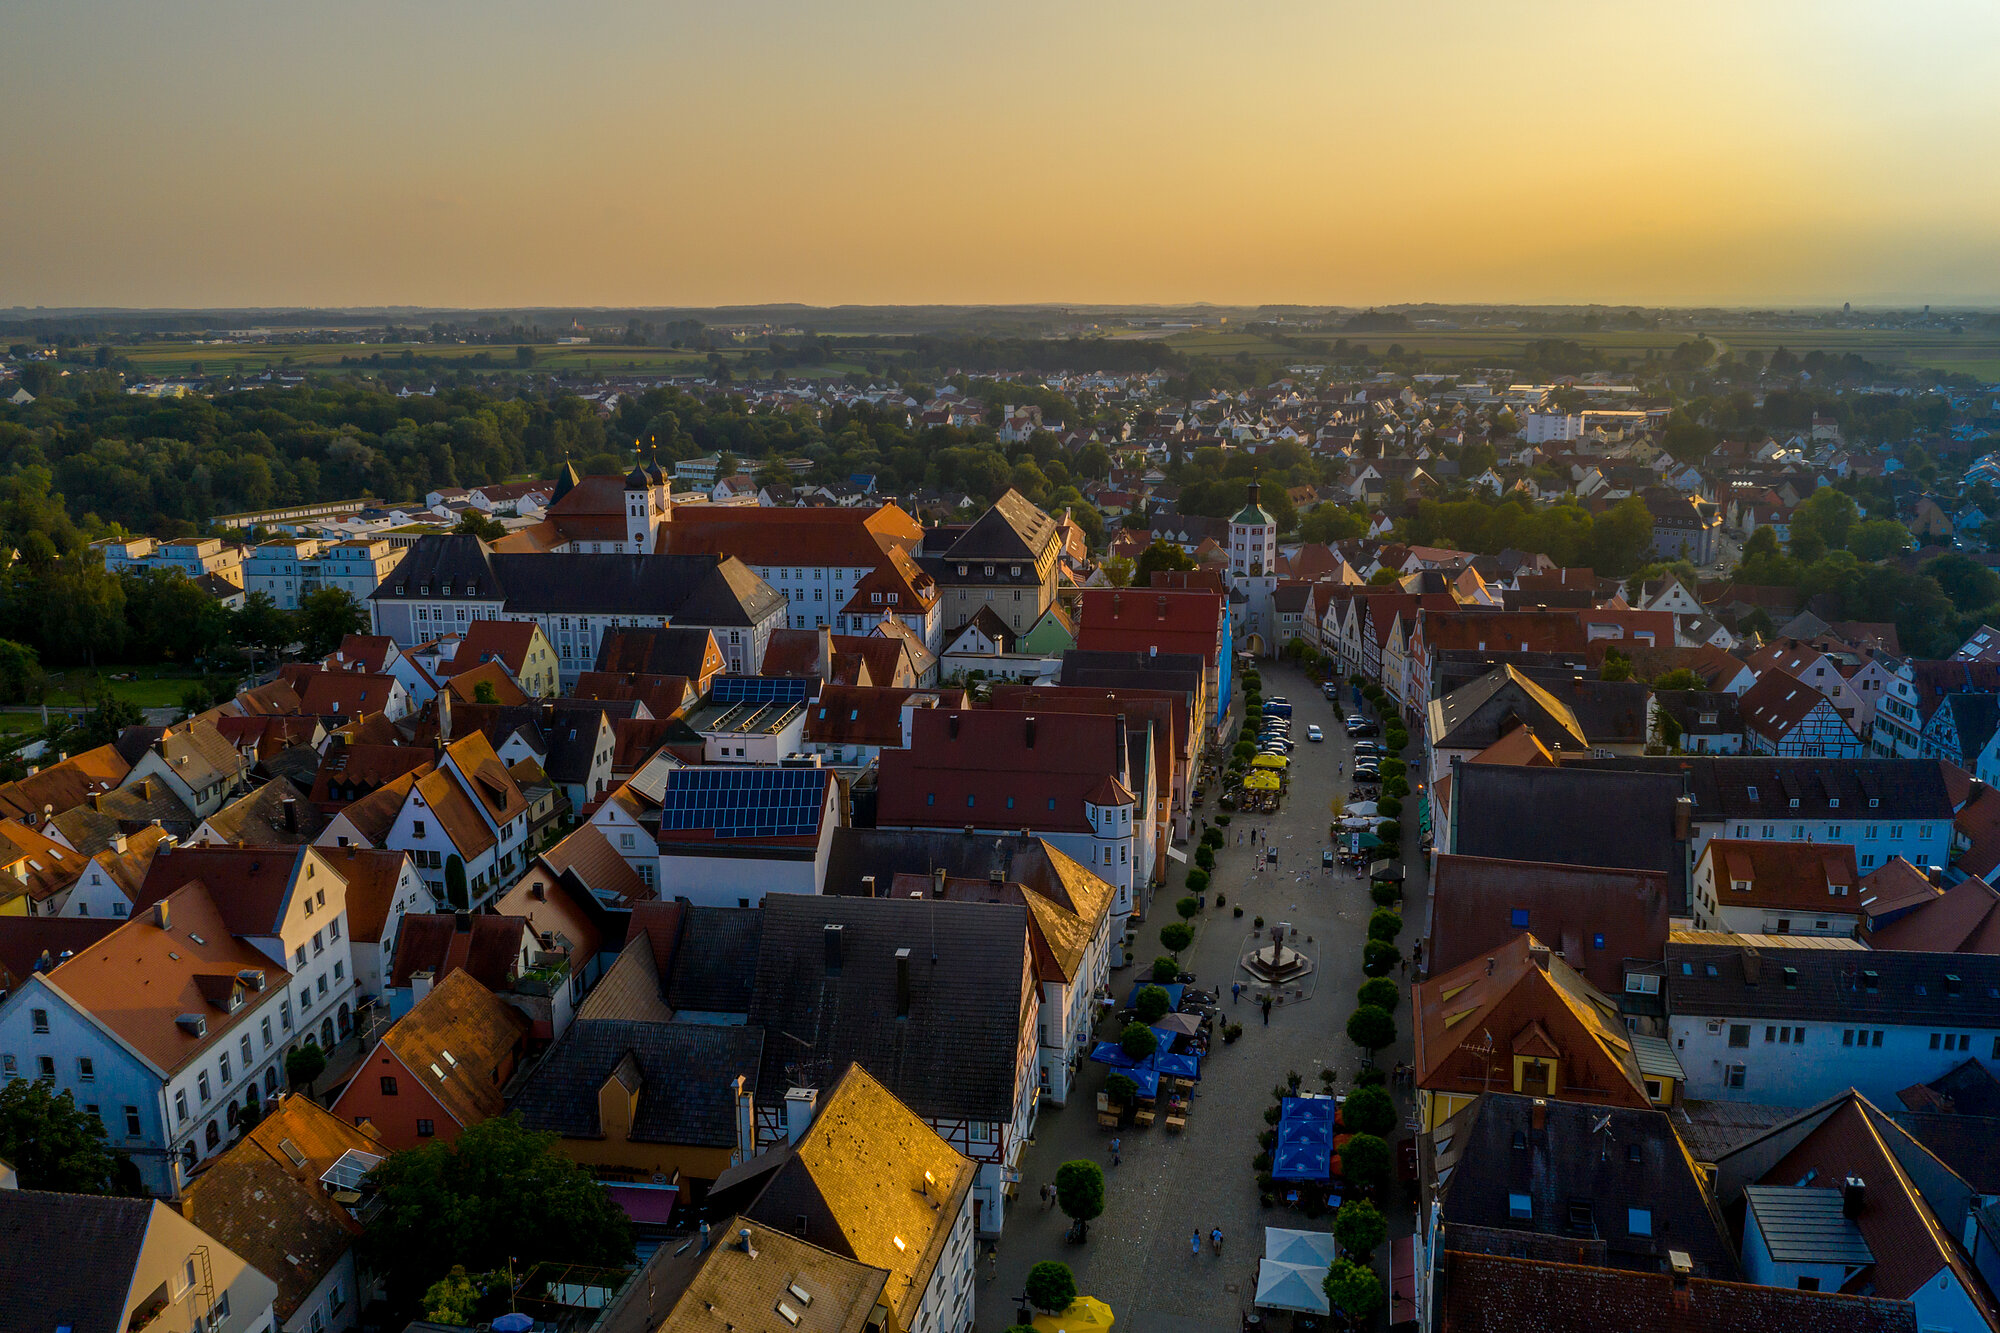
<box><xmin>1438</xmin><ymin>1093</ymin><xmax>1738</xmax><ymax>1279</ymax></box>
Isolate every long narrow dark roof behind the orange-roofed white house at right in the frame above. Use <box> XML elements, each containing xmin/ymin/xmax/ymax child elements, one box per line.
<box><xmin>1564</xmin><ymin>755</ymin><xmax>1952</xmax><ymax>821</ymax></box>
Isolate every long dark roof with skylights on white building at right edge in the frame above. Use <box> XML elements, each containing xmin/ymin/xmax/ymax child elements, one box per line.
<box><xmin>1666</xmin><ymin>941</ymin><xmax>2000</xmax><ymax>1029</ymax></box>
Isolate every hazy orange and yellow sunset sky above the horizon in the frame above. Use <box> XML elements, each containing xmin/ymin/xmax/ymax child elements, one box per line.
<box><xmin>0</xmin><ymin>0</ymin><xmax>2000</xmax><ymax>306</ymax></box>
